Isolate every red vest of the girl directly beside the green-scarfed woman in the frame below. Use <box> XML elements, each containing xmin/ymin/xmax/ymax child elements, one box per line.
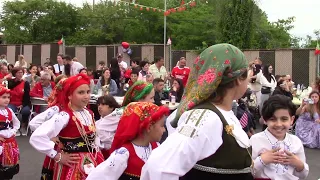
<box><xmin>123</xmin><ymin>142</ymin><xmax>158</xmax><ymax>177</ymax></box>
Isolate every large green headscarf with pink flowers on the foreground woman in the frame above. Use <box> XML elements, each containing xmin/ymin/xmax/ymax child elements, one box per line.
<box><xmin>171</xmin><ymin>44</ymin><xmax>248</xmax><ymax>128</ymax></box>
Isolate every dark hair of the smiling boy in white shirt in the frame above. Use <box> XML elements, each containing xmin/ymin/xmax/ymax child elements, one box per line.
<box><xmin>262</xmin><ymin>95</ymin><xmax>296</xmax><ymax>121</ymax></box>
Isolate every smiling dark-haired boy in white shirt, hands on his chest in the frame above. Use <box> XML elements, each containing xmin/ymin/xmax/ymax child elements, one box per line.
<box><xmin>250</xmin><ymin>95</ymin><xmax>309</xmax><ymax>180</ymax></box>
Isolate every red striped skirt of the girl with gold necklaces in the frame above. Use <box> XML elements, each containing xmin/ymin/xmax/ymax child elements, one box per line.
<box><xmin>53</xmin><ymin>152</ymin><xmax>104</xmax><ymax>180</ymax></box>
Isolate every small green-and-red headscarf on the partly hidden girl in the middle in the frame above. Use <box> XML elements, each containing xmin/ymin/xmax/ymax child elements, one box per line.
<box><xmin>122</xmin><ymin>81</ymin><xmax>153</xmax><ymax>106</ymax></box>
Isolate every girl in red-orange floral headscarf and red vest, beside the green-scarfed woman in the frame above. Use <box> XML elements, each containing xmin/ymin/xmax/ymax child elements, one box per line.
<box><xmin>87</xmin><ymin>102</ymin><xmax>169</xmax><ymax>180</ymax></box>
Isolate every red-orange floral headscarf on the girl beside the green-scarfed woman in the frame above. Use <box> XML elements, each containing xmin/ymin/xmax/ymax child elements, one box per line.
<box><xmin>110</xmin><ymin>102</ymin><xmax>169</xmax><ymax>153</ymax></box>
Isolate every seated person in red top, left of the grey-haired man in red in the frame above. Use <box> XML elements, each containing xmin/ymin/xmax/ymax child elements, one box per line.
<box><xmin>8</xmin><ymin>67</ymin><xmax>31</xmax><ymax>136</ymax></box>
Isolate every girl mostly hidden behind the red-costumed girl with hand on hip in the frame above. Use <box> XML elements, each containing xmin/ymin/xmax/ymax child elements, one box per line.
<box><xmin>29</xmin><ymin>78</ymin><xmax>67</xmax><ymax>180</ymax></box>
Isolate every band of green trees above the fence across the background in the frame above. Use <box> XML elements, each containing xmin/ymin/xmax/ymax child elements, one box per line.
<box><xmin>0</xmin><ymin>0</ymin><xmax>300</xmax><ymax>51</ymax></box>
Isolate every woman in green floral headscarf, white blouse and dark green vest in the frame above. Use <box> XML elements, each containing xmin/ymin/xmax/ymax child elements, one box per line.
<box><xmin>141</xmin><ymin>44</ymin><xmax>253</xmax><ymax>180</ymax></box>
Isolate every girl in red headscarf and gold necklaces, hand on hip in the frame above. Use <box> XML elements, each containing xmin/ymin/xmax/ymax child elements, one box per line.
<box><xmin>30</xmin><ymin>74</ymin><xmax>103</xmax><ymax>180</ymax></box>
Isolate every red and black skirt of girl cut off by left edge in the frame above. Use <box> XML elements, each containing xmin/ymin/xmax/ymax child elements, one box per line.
<box><xmin>0</xmin><ymin>137</ymin><xmax>20</xmax><ymax>179</ymax></box>
